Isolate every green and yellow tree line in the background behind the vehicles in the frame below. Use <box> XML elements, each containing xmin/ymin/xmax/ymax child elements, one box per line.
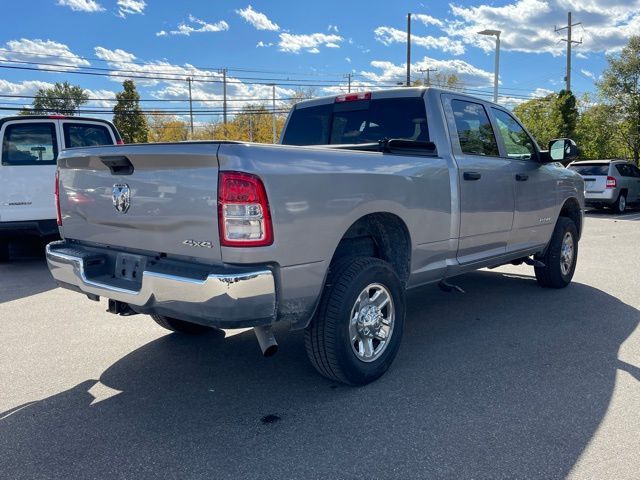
<box><xmin>13</xmin><ymin>36</ymin><xmax>640</xmax><ymax>164</ymax></box>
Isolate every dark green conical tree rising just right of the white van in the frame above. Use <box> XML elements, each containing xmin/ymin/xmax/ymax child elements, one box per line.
<box><xmin>113</xmin><ymin>80</ymin><xmax>149</xmax><ymax>143</ymax></box>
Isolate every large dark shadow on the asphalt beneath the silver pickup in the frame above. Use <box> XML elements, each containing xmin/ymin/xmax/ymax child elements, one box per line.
<box><xmin>0</xmin><ymin>272</ymin><xmax>640</xmax><ymax>479</ymax></box>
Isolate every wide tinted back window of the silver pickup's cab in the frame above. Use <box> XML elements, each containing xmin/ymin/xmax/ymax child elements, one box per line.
<box><xmin>282</xmin><ymin>97</ymin><xmax>429</xmax><ymax>145</ymax></box>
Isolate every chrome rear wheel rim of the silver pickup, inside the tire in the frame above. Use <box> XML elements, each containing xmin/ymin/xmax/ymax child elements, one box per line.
<box><xmin>349</xmin><ymin>283</ymin><xmax>395</xmax><ymax>362</ymax></box>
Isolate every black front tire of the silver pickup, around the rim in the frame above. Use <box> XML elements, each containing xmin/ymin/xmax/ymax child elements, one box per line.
<box><xmin>535</xmin><ymin>217</ymin><xmax>578</xmax><ymax>288</ymax></box>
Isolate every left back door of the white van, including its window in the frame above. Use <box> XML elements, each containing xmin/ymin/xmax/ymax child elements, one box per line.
<box><xmin>0</xmin><ymin>119</ymin><xmax>59</xmax><ymax>222</ymax></box>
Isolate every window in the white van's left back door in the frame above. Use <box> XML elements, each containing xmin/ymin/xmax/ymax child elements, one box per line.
<box><xmin>2</xmin><ymin>122</ymin><xmax>58</xmax><ymax>165</ymax></box>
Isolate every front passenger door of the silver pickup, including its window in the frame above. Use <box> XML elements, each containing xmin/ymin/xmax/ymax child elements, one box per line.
<box><xmin>491</xmin><ymin>107</ymin><xmax>558</xmax><ymax>252</ymax></box>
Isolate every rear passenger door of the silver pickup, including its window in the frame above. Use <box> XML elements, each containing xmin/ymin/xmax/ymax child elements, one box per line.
<box><xmin>445</xmin><ymin>96</ymin><xmax>515</xmax><ymax>263</ymax></box>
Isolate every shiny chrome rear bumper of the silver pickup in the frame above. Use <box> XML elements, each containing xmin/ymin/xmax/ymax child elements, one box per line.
<box><xmin>46</xmin><ymin>241</ymin><xmax>276</xmax><ymax>328</ymax></box>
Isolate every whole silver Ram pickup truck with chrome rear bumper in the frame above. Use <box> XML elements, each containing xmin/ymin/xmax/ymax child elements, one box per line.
<box><xmin>47</xmin><ymin>88</ymin><xmax>584</xmax><ymax>385</ymax></box>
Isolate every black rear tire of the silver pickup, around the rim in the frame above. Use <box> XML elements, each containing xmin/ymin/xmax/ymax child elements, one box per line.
<box><xmin>305</xmin><ymin>257</ymin><xmax>405</xmax><ymax>385</ymax></box>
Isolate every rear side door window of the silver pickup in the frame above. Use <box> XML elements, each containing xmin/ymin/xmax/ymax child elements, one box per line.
<box><xmin>451</xmin><ymin>100</ymin><xmax>500</xmax><ymax>157</ymax></box>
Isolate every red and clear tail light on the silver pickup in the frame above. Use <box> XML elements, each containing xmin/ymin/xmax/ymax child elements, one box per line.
<box><xmin>218</xmin><ymin>172</ymin><xmax>273</xmax><ymax>247</ymax></box>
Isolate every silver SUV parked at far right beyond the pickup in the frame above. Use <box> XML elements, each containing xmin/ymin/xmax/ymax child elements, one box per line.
<box><xmin>569</xmin><ymin>160</ymin><xmax>640</xmax><ymax>213</ymax></box>
